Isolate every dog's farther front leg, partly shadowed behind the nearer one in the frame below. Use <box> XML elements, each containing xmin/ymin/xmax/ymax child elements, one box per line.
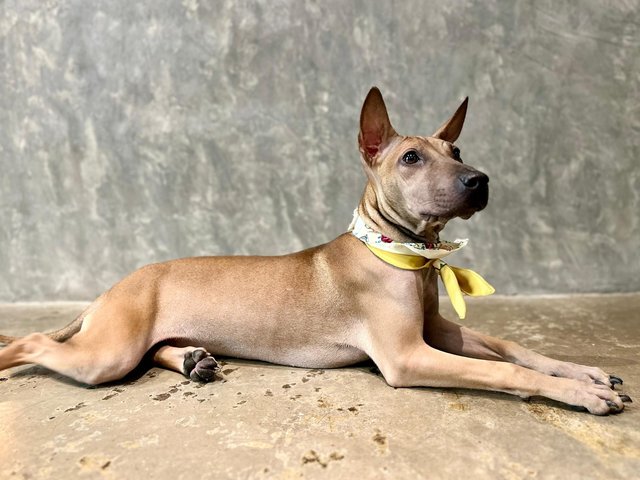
<box><xmin>424</xmin><ymin>315</ymin><xmax>622</xmax><ymax>387</ymax></box>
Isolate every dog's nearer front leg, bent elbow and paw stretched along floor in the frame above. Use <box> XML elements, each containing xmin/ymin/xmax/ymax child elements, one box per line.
<box><xmin>361</xmin><ymin>308</ymin><xmax>624</xmax><ymax>415</ymax></box>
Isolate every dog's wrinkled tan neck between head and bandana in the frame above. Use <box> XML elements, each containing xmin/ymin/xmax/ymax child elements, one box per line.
<box><xmin>358</xmin><ymin>182</ymin><xmax>446</xmax><ymax>243</ymax></box>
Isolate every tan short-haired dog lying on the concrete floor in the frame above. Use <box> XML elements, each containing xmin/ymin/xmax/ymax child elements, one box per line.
<box><xmin>0</xmin><ymin>87</ymin><xmax>631</xmax><ymax>415</ymax></box>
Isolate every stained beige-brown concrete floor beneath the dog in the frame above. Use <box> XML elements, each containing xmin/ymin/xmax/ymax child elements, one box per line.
<box><xmin>0</xmin><ymin>294</ymin><xmax>640</xmax><ymax>480</ymax></box>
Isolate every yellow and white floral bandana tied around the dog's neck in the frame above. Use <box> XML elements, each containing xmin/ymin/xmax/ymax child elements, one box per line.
<box><xmin>349</xmin><ymin>210</ymin><xmax>495</xmax><ymax>319</ymax></box>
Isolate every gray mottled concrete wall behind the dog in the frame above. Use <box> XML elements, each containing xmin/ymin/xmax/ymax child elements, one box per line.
<box><xmin>0</xmin><ymin>0</ymin><xmax>640</xmax><ymax>301</ymax></box>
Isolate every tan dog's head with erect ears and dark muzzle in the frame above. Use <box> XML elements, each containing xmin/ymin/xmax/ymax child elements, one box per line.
<box><xmin>358</xmin><ymin>87</ymin><xmax>489</xmax><ymax>237</ymax></box>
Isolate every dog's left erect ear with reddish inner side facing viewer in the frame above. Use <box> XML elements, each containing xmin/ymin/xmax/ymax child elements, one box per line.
<box><xmin>358</xmin><ymin>87</ymin><xmax>397</xmax><ymax>164</ymax></box>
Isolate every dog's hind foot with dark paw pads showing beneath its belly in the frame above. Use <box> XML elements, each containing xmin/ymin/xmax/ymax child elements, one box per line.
<box><xmin>153</xmin><ymin>345</ymin><xmax>220</xmax><ymax>382</ymax></box>
